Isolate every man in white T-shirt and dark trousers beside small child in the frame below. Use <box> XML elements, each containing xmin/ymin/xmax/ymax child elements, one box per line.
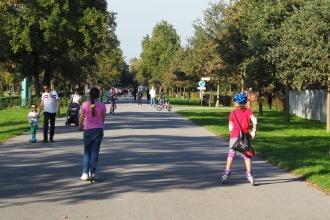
<box><xmin>39</xmin><ymin>84</ymin><xmax>61</xmax><ymax>143</ymax></box>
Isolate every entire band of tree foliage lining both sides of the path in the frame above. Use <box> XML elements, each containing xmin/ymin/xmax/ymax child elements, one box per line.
<box><xmin>0</xmin><ymin>0</ymin><xmax>330</xmax><ymax>130</ymax></box>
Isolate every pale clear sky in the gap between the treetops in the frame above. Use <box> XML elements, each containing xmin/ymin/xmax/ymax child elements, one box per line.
<box><xmin>107</xmin><ymin>0</ymin><xmax>218</xmax><ymax>64</ymax></box>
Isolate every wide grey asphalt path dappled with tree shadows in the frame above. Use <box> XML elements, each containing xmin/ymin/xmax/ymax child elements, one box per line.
<box><xmin>0</xmin><ymin>97</ymin><xmax>330</xmax><ymax>220</ymax></box>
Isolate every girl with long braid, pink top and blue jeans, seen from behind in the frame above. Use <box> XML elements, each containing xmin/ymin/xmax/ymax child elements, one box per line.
<box><xmin>79</xmin><ymin>88</ymin><xmax>107</xmax><ymax>180</ymax></box>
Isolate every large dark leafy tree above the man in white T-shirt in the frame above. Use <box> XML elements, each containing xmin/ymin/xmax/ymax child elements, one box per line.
<box><xmin>3</xmin><ymin>0</ymin><xmax>106</xmax><ymax>95</ymax></box>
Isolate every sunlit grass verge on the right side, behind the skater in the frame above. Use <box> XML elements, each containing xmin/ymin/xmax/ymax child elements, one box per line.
<box><xmin>178</xmin><ymin>108</ymin><xmax>330</xmax><ymax>193</ymax></box>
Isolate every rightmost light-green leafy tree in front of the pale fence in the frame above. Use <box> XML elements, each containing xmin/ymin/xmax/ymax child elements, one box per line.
<box><xmin>268</xmin><ymin>1</ymin><xmax>330</xmax><ymax>126</ymax></box>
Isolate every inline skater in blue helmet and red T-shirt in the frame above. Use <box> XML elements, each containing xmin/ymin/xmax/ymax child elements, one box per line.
<box><xmin>222</xmin><ymin>94</ymin><xmax>257</xmax><ymax>185</ymax></box>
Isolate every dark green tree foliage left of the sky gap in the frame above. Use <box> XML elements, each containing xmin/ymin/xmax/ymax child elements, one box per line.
<box><xmin>0</xmin><ymin>0</ymin><xmax>127</xmax><ymax>95</ymax></box>
